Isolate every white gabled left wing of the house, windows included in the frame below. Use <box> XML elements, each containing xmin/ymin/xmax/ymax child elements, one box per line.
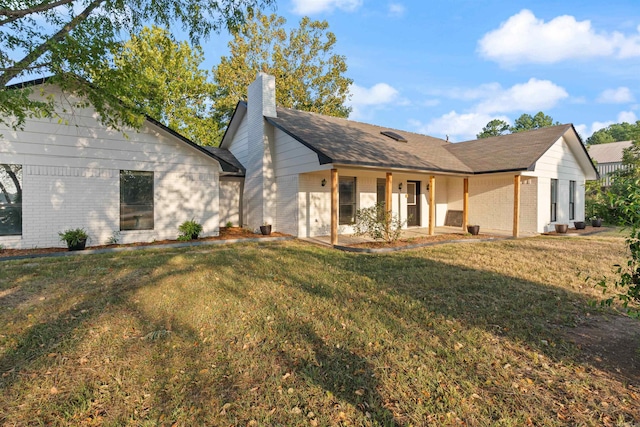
<box><xmin>0</xmin><ymin>80</ymin><xmax>244</xmax><ymax>248</ymax></box>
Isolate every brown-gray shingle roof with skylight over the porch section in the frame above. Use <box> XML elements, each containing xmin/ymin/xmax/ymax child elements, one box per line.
<box><xmin>266</xmin><ymin>107</ymin><xmax>573</xmax><ymax>174</ymax></box>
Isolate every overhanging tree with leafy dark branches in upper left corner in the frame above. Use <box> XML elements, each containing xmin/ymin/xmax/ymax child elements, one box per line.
<box><xmin>0</xmin><ymin>0</ymin><xmax>275</xmax><ymax>128</ymax></box>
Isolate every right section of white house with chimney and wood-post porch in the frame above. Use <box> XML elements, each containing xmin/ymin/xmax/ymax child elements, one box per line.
<box><xmin>221</xmin><ymin>73</ymin><xmax>597</xmax><ymax>243</ymax></box>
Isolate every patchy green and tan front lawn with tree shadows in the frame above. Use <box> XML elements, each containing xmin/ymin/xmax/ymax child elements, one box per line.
<box><xmin>0</xmin><ymin>236</ymin><xmax>640</xmax><ymax>426</ymax></box>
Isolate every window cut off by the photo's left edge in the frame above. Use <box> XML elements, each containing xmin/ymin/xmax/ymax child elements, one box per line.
<box><xmin>0</xmin><ymin>163</ymin><xmax>22</xmax><ymax>236</ymax></box>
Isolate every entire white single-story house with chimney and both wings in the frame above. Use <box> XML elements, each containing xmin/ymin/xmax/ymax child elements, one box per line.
<box><xmin>0</xmin><ymin>73</ymin><xmax>597</xmax><ymax>248</ymax></box>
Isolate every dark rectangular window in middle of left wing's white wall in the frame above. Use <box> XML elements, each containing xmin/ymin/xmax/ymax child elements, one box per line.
<box><xmin>120</xmin><ymin>171</ymin><xmax>153</xmax><ymax>230</ymax></box>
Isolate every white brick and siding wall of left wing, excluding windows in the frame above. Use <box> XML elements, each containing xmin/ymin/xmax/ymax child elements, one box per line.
<box><xmin>0</xmin><ymin>86</ymin><xmax>220</xmax><ymax>248</ymax></box>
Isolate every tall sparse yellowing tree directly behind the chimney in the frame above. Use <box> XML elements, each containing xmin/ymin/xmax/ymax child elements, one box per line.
<box><xmin>213</xmin><ymin>12</ymin><xmax>353</xmax><ymax>129</ymax></box>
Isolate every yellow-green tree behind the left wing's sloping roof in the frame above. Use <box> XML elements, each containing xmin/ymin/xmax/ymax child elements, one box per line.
<box><xmin>92</xmin><ymin>26</ymin><xmax>218</xmax><ymax>145</ymax></box>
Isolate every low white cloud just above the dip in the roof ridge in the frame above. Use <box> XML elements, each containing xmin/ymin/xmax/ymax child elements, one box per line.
<box><xmin>410</xmin><ymin>111</ymin><xmax>510</xmax><ymax>142</ymax></box>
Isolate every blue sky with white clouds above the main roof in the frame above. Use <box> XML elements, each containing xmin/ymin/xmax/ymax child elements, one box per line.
<box><xmin>203</xmin><ymin>0</ymin><xmax>640</xmax><ymax>141</ymax></box>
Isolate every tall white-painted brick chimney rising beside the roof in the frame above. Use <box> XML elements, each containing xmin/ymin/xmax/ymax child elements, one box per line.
<box><xmin>245</xmin><ymin>72</ymin><xmax>277</xmax><ymax>234</ymax></box>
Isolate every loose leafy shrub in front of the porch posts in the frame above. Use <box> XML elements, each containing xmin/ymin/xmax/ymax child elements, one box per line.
<box><xmin>353</xmin><ymin>203</ymin><xmax>406</xmax><ymax>243</ymax></box>
